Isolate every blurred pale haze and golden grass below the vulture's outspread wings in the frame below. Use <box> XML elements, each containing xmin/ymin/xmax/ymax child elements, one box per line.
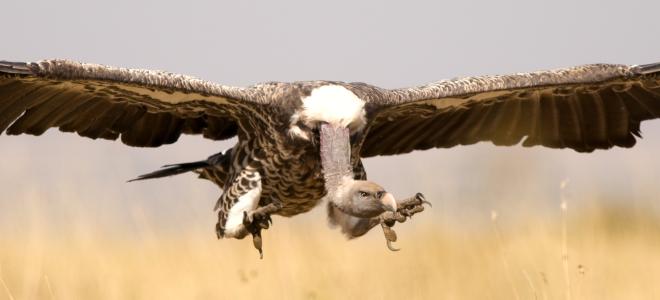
<box><xmin>0</xmin><ymin>131</ymin><xmax>660</xmax><ymax>300</ymax></box>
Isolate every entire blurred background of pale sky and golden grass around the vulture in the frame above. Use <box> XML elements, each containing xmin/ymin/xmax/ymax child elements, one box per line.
<box><xmin>0</xmin><ymin>0</ymin><xmax>660</xmax><ymax>299</ymax></box>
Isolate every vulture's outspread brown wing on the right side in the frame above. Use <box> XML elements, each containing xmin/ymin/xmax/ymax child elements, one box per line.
<box><xmin>361</xmin><ymin>63</ymin><xmax>660</xmax><ymax>157</ymax></box>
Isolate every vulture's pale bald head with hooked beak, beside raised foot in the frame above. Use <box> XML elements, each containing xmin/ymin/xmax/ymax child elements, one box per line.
<box><xmin>330</xmin><ymin>178</ymin><xmax>397</xmax><ymax>218</ymax></box>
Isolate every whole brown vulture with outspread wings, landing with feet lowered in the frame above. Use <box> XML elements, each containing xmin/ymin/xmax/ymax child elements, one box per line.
<box><xmin>0</xmin><ymin>60</ymin><xmax>660</xmax><ymax>257</ymax></box>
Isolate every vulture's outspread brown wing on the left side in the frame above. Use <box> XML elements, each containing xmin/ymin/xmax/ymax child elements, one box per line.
<box><xmin>0</xmin><ymin>60</ymin><xmax>264</xmax><ymax>147</ymax></box>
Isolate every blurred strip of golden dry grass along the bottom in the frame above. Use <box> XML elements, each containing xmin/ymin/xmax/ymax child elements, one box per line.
<box><xmin>0</xmin><ymin>203</ymin><xmax>660</xmax><ymax>299</ymax></box>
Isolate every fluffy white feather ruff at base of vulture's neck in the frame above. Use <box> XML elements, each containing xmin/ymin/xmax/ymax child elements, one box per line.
<box><xmin>300</xmin><ymin>85</ymin><xmax>366</xmax><ymax>129</ymax></box>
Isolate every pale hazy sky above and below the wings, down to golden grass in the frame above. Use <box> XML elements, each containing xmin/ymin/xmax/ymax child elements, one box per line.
<box><xmin>0</xmin><ymin>0</ymin><xmax>660</xmax><ymax>232</ymax></box>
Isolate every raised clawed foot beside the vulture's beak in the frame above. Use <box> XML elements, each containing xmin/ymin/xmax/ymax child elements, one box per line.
<box><xmin>379</xmin><ymin>193</ymin><xmax>432</xmax><ymax>251</ymax></box>
